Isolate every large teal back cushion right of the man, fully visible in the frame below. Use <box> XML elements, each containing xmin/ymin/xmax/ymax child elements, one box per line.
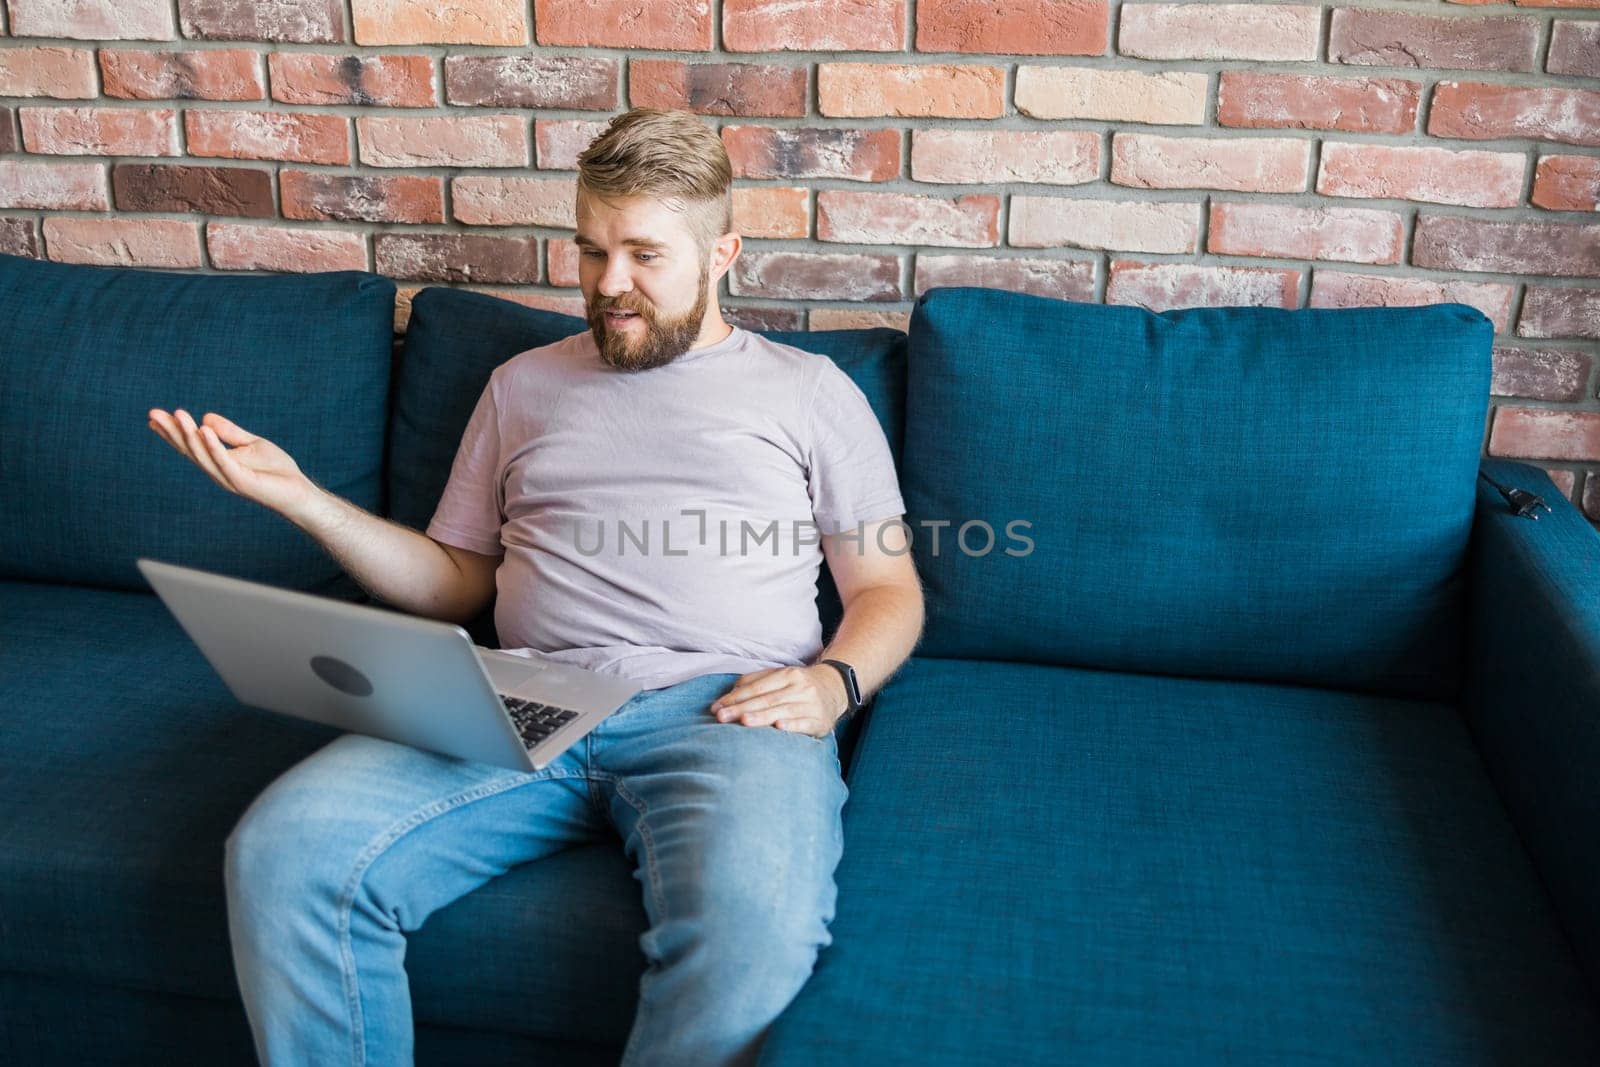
<box><xmin>901</xmin><ymin>288</ymin><xmax>1493</xmax><ymax>697</ymax></box>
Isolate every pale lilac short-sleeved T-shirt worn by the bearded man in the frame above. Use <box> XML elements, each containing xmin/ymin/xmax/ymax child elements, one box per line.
<box><xmin>427</xmin><ymin>326</ymin><xmax>906</xmax><ymax>689</ymax></box>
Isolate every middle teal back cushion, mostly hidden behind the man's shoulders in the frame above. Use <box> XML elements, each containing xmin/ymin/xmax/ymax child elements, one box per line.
<box><xmin>389</xmin><ymin>286</ymin><xmax>906</xmax><ymax>645</ymax></box>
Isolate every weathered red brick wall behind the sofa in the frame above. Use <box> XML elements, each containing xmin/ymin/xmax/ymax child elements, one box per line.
<box><xmin>0</xmin><ymin>0</ymin><xmax>1600</xmax><ymax>522</ymax></box>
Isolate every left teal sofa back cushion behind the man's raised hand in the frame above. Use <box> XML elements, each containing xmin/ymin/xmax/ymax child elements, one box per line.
<box><xmin>0</xmin><ymin>256</ymin><xmax>395</xmax><ymax>592</ymax></box>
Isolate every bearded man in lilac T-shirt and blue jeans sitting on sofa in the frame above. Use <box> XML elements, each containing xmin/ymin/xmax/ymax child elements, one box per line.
<box><xmin>150</xmin><ymin>109</ymin><xmax>923</xmax><ymax>1067</ymax></box>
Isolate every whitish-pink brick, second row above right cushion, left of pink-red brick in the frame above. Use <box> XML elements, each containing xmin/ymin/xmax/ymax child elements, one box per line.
<box><xmin>1006</xmin><ymin>194</ymin><xmax>1200</xmax><ymax>254</ymax></box>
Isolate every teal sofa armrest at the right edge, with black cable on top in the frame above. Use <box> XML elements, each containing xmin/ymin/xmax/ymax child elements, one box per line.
<box><xmin>1461</xmin><ymin>461</ymin><xmax>1600</xmax><ymax>990</ymax></box>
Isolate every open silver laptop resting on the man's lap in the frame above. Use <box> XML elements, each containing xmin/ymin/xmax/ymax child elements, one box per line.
<box><xmin>136</xmin><ymin>558</ymin><xmax>642</xmax><ymax>771</ymax></box>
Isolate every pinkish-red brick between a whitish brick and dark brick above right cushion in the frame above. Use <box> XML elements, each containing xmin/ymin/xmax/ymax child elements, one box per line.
<box><xmin>1206</xmin><ymin>202</ymin><xmax>1405</xmax><ymax>264</ymax></box>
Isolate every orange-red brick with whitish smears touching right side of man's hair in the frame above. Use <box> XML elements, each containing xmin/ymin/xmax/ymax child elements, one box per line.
<box><xmin>722</xmin><ymin>126</ymin><xmax>901</xmax><ymax>181</ymax></box>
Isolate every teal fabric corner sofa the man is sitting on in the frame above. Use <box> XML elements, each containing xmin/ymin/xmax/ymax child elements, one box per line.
<box><xmin>0</xmin><ymin>256</ymin><xmax>1600</xmax><ymax>1067</ymax></box>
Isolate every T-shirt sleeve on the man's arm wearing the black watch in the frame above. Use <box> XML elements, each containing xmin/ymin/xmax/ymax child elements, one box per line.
<box><xmin>806</xmin><ymin>364</ymin><xmax>906</xmax><ymax>534</ymax></box>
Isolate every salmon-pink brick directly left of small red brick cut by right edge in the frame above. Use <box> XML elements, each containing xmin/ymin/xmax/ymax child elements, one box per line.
<box><xmin>1317</xmin><ymin>141</ymin><xmax>1528</xmax><ymax>208</ymax></box>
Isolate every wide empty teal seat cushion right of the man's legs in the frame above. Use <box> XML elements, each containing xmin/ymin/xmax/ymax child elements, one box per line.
<box><xmin>762</xmin><ymin>659</ymin><xmax>1600</xmax><ymax>1067</ymax></box>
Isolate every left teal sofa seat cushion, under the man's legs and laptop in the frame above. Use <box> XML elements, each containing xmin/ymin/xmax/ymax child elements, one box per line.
<box><xmin>0</xmin><ymin>582</ymin><xmax>646</xmax><ymax>1045</ymax></box>
